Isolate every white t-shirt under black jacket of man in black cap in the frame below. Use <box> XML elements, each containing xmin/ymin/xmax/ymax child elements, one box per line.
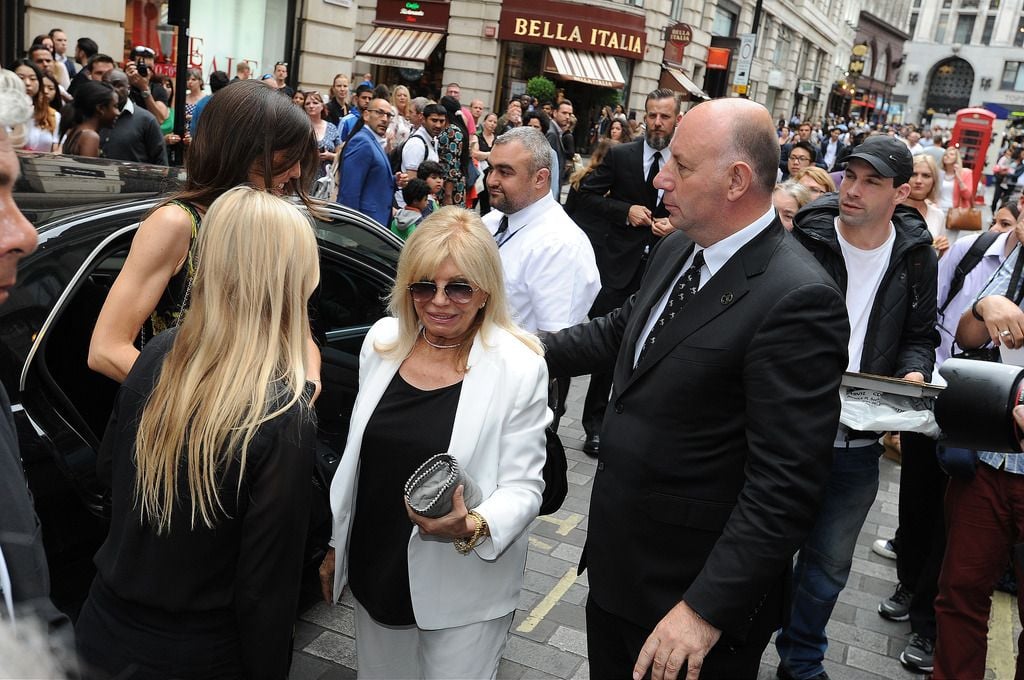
<box><xmin>836</xmin><ymin>217</ymin><xmax>896</xmax><ymax>371</ymax></box>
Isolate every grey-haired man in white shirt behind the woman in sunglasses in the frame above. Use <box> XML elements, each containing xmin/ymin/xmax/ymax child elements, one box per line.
<box><xmin>483</xmin><ymin>126</ymin><xmax>601</xmax><ymax>431</ymax></box>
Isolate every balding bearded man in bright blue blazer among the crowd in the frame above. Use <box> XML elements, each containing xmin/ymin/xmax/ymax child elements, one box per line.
<box><xmin>338</xmin><ymin>99</ymin><xmax>395</xmax><ymax>226</ymax></box>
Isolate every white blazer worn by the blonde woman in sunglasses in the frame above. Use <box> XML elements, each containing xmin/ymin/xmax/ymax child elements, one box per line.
<box><xmin>331</xmin><ymin>317</ymin><xmax>552</xmax><ymax>630</ymax></box>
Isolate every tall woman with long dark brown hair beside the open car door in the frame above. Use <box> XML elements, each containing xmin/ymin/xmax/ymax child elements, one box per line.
<box><xmin>89</xmin><ymin>80</ymin><xmax>319</xmax><ymax>388</ymax></box>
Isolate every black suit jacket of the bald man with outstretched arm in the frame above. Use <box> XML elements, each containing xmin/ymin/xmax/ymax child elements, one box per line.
<box><xmin>543</xmin><ymin>219</ymin><xmax>849</xmax><ymax>654</ymax></box>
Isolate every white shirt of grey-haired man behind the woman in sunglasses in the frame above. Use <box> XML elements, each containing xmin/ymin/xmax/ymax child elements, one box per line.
<box><xmin>483</xmin><ymin>194</ymin><xmax>601</xmax><ymax>333</ymax></box>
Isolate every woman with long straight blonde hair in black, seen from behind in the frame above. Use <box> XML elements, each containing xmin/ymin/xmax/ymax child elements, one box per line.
<box><xmin>76</xmin><ymin>186</ymin><xmax>319</xmax><ymax>678</ymax></box>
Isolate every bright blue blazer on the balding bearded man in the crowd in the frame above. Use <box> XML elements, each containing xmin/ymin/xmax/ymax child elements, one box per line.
<box><xmin>338</xmin><ymin>127</ymin><xmax>395</xmax><ymax>226</ymax></box>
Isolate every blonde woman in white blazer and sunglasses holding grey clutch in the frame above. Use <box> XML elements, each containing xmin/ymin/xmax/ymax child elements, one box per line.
<box><xmin>321</xmin><ymin>208</ymin><xmax>551</xmax><ymax>679</ymax></box>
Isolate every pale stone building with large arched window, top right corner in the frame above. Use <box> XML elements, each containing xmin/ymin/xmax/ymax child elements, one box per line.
<box><xmin>894</xmin><ymin>0</ymin><xmax>1024</xmax><ymax>127</ymax></box>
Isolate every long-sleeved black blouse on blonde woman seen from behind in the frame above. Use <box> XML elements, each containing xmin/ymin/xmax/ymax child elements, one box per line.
<box><xmin>95</xmin><ymin>330</ymin><xmax>316</xmax><ymax>678</ymax></box>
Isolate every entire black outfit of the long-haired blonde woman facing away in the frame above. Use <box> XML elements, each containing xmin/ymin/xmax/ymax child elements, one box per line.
<box><xmin>76</xmin><ymin>330</ymin><xmax>316</xmax><ymax>680</ymax></box>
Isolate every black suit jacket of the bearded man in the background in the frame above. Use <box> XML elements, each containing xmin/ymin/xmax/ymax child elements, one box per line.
<box><xmin>578</xmin><ymin>139</ymin><xmax>657</xmax><ymax>293</ymax></box>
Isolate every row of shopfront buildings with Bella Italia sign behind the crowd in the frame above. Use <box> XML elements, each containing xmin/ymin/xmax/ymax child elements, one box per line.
<box><xmin>2</xmin><ymin>0</ymin><xmax>921</xmax><ymax>132</ymax></box>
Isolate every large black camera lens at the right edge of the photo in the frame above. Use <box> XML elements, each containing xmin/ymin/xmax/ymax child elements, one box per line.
<box><xmin>935</xmin><ymin>358</ymin><xmax>1024</xmax><ymax>453</ymax></box>
